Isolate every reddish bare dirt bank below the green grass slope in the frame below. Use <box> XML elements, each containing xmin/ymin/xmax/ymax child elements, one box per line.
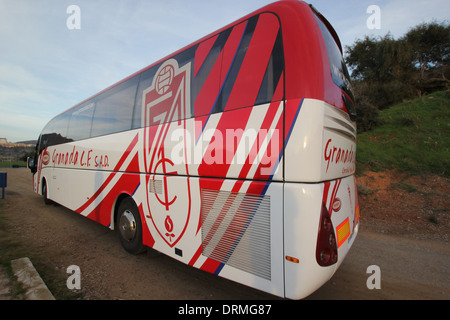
<box><xmin>357</xmin><ymin>171</ymin><xmax>450</xmax><ymax>242</ymax></box>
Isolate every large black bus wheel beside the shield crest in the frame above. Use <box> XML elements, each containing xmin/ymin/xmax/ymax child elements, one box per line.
<box><xmin>116</xmin><ymin>198</ymin><xmax>145</xmax><ymax>254</ymax></box>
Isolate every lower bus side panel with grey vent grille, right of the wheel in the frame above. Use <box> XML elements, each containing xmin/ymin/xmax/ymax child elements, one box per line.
<box><xmin>139</xmin><ymin>175</ymin><xmax>284</xmax><ymax>295</ymax></box>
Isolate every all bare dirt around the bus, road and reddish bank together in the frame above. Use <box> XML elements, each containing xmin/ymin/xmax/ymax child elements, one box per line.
<box><xmin>0</xmin><ymin>169</ymin><xmax>450</xmax><ymax>300</ymax></box>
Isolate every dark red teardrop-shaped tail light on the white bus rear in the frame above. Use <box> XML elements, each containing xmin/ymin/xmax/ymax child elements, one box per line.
<box><xmin>316</xmin><ymin>203</ymin><xmax>337</xmax><ymax>267</ymax></box>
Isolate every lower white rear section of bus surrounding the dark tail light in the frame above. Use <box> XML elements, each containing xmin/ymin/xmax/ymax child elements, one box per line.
<box><xmin>284</xmin><ymin>176</ymin><xmax>359</xmax><ymax>299</ymax></box>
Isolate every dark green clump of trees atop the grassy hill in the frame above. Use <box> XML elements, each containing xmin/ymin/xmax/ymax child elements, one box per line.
<box><xmin>345</xmin><ymin>22</ymin><xmax>450</xmax><ymax>115</ymax></box>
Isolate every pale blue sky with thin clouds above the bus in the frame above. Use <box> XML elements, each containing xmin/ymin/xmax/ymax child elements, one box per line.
<box><xmin>0</xmin><ymin>0</ymin><xmax>450</xmax><ymax>142</ymax></box>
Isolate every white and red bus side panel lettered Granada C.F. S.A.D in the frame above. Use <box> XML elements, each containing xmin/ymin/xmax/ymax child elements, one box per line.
<box><xmin>35</xmin><ymin>131</ymin><xmax>140</xmax><ymax>227</ymax></box>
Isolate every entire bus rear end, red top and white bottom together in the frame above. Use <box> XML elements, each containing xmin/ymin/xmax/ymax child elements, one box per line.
<box><xmin>280</xmin><ymin>2</ymin><xmax>359</xmax><ymax>299</ymax></box>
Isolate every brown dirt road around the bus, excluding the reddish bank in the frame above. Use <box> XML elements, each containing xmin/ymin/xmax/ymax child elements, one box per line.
<box><xmin>0</xmin><ymin>169</ymin><xmax>450</xmax><ymax>300</ymax></box>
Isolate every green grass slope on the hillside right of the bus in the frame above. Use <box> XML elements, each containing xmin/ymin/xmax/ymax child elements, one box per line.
<box><xmin>357</xmin><ymin>91</ymin><xmax>450</xmax><ymax>177</ymax></box>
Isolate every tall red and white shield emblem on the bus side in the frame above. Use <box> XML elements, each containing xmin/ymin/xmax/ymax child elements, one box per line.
<box><xmin>142</xmin><ymin>59</ymin><xmax>191</xmax><ymax>247</ymax></box>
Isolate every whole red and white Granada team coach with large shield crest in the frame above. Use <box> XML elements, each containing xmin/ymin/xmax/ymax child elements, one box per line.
<box><xmin>29</xmin><ymin>0</ymin><xmax>359</xmax><ymax>299</ymax></box>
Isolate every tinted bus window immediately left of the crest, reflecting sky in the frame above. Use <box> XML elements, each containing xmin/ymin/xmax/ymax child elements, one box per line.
<box><xmin>91</xmin><ymin>76</ymin><xmax>139</xmax><ymax>137</ymax></box>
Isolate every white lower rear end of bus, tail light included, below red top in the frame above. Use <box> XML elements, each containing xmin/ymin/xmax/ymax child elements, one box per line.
<box><xmin>284</xmin><ymin>99</ymin><xmax>359</xmax><ymax>299</ymax></box>
